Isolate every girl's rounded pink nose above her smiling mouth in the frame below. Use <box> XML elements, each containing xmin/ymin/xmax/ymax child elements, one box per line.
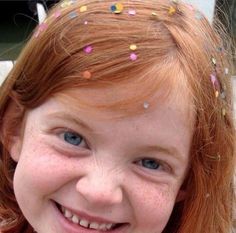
<box><xmin>76</xmin><ymin>169</ymin><xmax>123</xmax><ymax>206</ymax></box>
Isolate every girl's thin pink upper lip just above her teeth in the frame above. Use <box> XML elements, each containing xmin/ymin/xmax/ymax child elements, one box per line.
<box><xmin>59</xmin><ymin>204</ymin><xmax>119</xmax><ymax>224</ymax></box>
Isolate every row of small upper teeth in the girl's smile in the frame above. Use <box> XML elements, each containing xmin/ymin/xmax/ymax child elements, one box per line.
<box><xmin>62</xmin><ymin>207</ymin><xmax>115</xmax><ymax>231</ymax></box>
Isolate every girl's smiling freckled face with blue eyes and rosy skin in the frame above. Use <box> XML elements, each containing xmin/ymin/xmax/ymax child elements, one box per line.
<box><xmin>11</xmin><ymin>85</ymin><xmax>193</xmax><ymax>233</ymax></box>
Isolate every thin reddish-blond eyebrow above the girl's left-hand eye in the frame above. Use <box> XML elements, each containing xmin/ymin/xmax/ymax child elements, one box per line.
<box><xmin>46</xmin><ymin>112</ymin><xmax>93</xmax><ymax>131</ymax></box>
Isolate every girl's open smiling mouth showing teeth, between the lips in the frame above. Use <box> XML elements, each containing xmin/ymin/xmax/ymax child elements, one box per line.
<box><xmin>56</xmin><ymin>203</ymin><xmax>129</xmax><ymax>232</ymax></box>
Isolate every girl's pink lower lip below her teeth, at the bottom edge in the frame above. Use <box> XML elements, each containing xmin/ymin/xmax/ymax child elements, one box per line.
<box><xmin>54</xmin><ymin>202</ymin><xmax>129</xmax><ymax>233</ymax></box>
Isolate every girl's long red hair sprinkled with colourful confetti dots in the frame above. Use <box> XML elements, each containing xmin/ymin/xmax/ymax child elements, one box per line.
<box><xmin>0</xmin><ymin>0</ymin><xmax>236</xmax><ymax>233</ymax></box>
